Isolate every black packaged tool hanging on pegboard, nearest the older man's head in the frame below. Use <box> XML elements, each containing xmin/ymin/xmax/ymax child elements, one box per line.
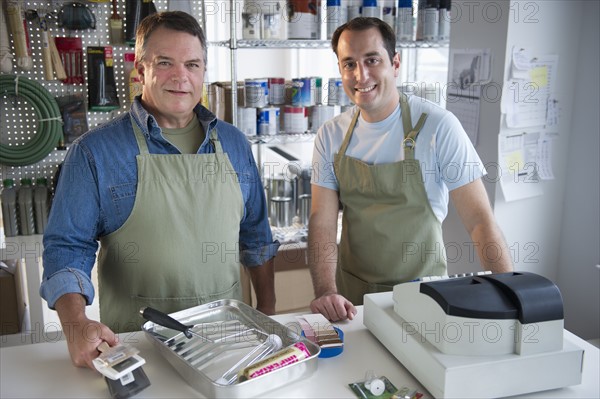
<box><xmin>87</xmin><ymin>46</ymin><xmax>119</xmax><ymax>111</ymax></box>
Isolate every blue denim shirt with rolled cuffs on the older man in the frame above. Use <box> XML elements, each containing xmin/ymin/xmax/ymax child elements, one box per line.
<box><xmin>40</xmin><ymin>98</ymin><xmax>279</xmax><ymax>309</ymax></box>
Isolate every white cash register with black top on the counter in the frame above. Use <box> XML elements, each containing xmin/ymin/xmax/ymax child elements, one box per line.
<box><xmin>364</xmin><ymin>272</ymin><xmax>584</xmax><ymax>398</ymax></box>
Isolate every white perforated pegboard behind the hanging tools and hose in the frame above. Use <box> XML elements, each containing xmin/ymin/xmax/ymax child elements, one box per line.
<box><xmin>0</xmin><ymin>0</ymin><xmax>203</xmax><ymax>189</ymax></box>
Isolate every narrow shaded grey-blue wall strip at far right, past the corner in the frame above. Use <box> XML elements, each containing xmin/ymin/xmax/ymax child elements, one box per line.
<box><xmin>558</xmin><ymin>1</ymin><xmax>600</xmax><ymax>339</ymax></box>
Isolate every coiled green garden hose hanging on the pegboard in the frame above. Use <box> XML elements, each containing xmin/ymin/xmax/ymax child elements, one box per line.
<box><xmin>0</xmin><ymin>75</ymin><xmax>63</xmax><ymax>166</ymax></box>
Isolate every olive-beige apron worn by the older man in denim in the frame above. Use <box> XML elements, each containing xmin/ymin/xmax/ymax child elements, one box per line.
<box><xmin>98</xmin><ymin>118</ymin><xmax>244</xmax><ymax>332</ymax></box>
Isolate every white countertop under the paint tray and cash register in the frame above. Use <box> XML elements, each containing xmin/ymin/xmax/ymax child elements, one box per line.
<box><xmin>0</xmin><ymin>306</ymin><xmax>600</xmax><ymax>399</ymax></box>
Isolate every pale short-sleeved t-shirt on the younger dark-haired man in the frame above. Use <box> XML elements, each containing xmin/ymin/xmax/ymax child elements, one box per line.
<box><xmin>311</xmin><ymin>96</ymin><xmax>486</xmax><ymax>222</ymax></box>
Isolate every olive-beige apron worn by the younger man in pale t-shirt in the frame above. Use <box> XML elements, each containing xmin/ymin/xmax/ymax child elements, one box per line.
<box><xmin>334</xmin><ymin>95</ymin><xmax>446</xmax><ymax>305</ymax></box>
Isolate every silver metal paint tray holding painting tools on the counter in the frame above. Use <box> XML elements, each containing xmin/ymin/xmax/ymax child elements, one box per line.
<box><xmin>142</xmin><ymin>299</ymin><xmax>321</xmax><ymax>398</ymax></box>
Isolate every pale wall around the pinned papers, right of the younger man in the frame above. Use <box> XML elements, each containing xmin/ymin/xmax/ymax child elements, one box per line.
<box><xmin>444</xmin><ymin>0</ymin><xmax>600</xmax><ymax>338</ymax></box>
